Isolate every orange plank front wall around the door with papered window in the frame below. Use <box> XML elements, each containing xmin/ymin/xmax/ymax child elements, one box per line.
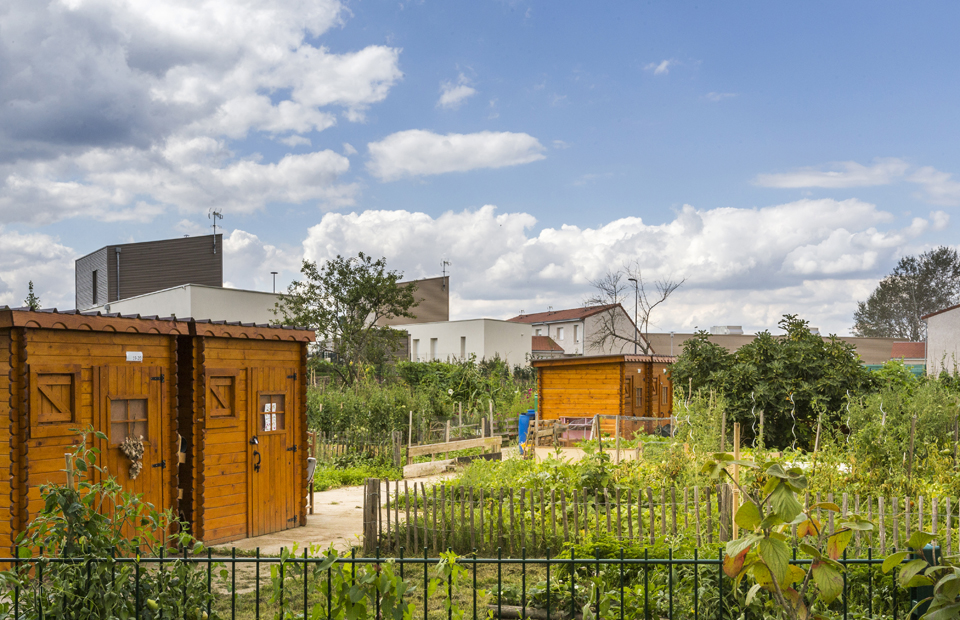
<box><xmin>194</xmin><ymin>337</ymin><xmax>305</xmax><ymax>544</ymax></box>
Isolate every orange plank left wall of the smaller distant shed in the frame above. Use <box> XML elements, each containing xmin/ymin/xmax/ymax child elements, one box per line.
<box><xmin>539</xmin><ymin>362</ymin><xmax>623</xmax><ymax>420</ymax></box>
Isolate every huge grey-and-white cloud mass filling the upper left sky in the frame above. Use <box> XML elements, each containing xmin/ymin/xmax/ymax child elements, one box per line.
<box><xmin>0</xmin><ymin>0</ymin><xmax>402</xmax><ymax>222</ymax></box>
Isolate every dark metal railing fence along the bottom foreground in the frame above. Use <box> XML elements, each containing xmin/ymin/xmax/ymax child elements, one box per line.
<box><xmin>0</xmin><ymin>549</ymin><xmax>912</xmax><ymax>620</ymax></box>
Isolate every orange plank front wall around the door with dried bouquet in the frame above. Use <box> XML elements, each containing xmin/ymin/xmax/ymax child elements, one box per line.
<box><xmin>19</xmin><ymin>329</ymin><xmax>177</xmax><ymax>527</ymax></box>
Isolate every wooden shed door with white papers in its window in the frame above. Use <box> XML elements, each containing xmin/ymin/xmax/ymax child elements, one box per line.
<box><xmin>248</xmin><ymin>368</ymin><xmax>299</xmax><ymax>536</ymax></box>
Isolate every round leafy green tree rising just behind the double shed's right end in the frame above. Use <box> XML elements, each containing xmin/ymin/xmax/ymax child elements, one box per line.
<box><xmin>274</xmin><ymin>252</ymin><xmax>417</xmax><ymax>383</ymax></box>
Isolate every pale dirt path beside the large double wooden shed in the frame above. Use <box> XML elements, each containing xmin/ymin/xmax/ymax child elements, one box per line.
<box><xmin>230</xmin><ymin>474</ymin><xmax>453</xmax><ymax>555</ymax></box>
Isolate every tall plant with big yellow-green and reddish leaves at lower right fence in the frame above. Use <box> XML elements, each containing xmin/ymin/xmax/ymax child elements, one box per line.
<box><xmin>703</xmin><ymin>453</ymin><xmax>873</xmax><ymax>620</ymax></box>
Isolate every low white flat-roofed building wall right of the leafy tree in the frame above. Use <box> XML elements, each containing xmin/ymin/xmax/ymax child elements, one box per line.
<box><xmin>393</xmin><ymin>319</ymin><xmax>533</xmax><ymax>366</ymax></box>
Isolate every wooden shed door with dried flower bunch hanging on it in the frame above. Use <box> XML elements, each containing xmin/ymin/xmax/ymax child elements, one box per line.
<box><xmin>95</xmin><ymin>366</ymin><xmax>167</xmax><ymax>510</ymax></box>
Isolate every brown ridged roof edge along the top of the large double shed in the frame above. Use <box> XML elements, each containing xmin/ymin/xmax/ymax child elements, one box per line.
<box><xmin>0</xmin><ymin>306</ymin><xmax>316</xmax><ymax>342</ymax></box>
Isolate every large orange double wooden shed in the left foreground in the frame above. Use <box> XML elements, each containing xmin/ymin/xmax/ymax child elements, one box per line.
<box><xmin>0</xmin><ymin>308</ymin><xmax>314</xmax><ymax>548</ymax></box>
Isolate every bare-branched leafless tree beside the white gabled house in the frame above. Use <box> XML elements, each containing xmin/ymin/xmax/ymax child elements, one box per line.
<box><xmin>584</xmin><ymin>261</ymin><xmax>686</xmax><ymax>354</ymax></box>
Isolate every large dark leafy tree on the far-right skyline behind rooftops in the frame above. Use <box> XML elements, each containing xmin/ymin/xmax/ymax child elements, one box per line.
<box><xmin>853</xmin><ymin>246</ymin><xmax>960</xmax><ymax>342</ymax></box>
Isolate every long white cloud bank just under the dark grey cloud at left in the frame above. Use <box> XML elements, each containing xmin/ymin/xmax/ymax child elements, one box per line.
<box><xmin>0</xmin><ymin>138</ymin><xmax>356</xmax><ymax>224</ymax></box>
